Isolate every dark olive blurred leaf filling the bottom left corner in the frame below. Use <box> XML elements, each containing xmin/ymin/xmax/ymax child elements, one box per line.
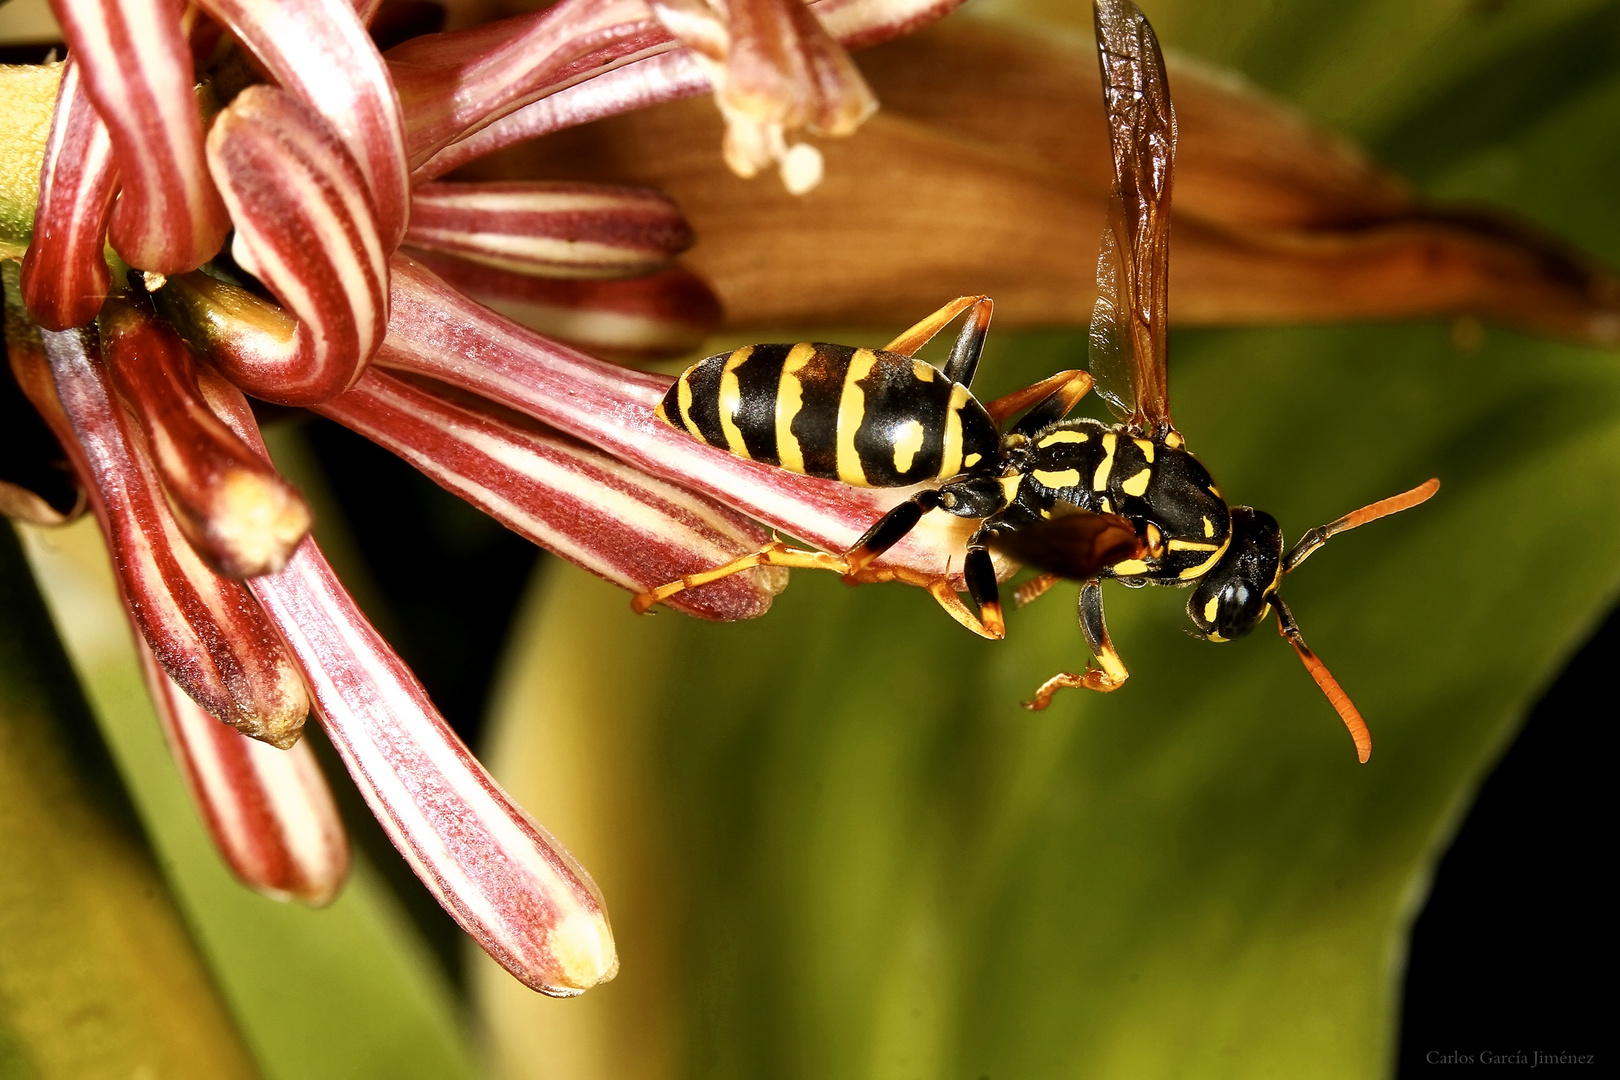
<box><xmin>0</xmin><ymin>528</ymin><xmax>258</xmax><ymax>1080</ymax></box>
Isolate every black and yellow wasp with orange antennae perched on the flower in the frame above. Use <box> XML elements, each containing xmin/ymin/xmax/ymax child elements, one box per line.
<box><xmin>635</xmin><ymin>0</ymin><xmax>1440</xmax><ymax>761</ymax></box>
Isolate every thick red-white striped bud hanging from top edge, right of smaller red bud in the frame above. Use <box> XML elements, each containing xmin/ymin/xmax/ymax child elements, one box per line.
<box><xmin>52</xmin><ymin>0</ymin><xmax>230</xmax><ymax>274</ymax></box>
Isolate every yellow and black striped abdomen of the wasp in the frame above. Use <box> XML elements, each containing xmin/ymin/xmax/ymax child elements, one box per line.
<box><xmin>658</xmin><ymin>342</ymin><xmax>1000</xmax><ymax>487</ymax></box>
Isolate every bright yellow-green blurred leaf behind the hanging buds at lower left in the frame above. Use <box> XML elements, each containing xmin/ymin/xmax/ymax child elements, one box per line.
<box><xmin>14</xmin><ymin>520</ymin><xmax>480</xmax><ymax>1080</ymax></box>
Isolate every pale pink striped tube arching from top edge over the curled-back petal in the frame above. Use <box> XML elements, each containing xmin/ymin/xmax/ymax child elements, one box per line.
<box><xmin>198</xmin><ymin>0</ymin><xmax>410</xmax><ymax>251</ymax></box>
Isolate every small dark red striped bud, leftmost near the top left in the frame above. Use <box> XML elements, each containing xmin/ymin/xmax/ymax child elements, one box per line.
<box><xmin>23</xmin><ymin>58</ymin><xmax>118</xmax><ymax>330</ymax></box>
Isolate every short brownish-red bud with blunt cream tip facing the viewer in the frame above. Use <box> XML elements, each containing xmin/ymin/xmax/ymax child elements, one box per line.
<box><xmin>100</xmin><ymin>296</ymin><xmax>311</xmax><ymax>578</ymax></box>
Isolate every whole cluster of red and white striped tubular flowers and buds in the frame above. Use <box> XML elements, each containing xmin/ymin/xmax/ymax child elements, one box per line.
<box><xmin>0</xmin><ymin>0</ymin><xmax>956</xmax><ymax>996</ymax></box>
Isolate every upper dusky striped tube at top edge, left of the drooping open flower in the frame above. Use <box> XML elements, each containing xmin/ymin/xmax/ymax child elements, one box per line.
<box><xmin>387</xmin><ymin>0</ymin><xmax>669</xmax><ymax>167</ymax></box>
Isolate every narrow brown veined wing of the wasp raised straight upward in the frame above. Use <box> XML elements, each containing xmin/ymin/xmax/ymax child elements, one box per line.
<box><xmin>1092</xmin><ymin>0</ymin><xmax>1176</xmax><ymax>436</ymax></box>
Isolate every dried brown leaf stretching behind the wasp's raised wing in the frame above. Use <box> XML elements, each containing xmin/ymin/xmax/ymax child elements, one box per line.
<box><xmin>456</xmin><ymin>18</ymin><xmax>1620</xmax><ymax>343</ymax></box>
